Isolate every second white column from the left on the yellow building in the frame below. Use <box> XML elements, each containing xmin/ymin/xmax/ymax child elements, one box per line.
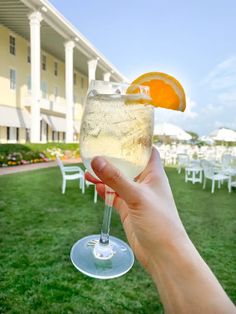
<box><xmin>65</xmin><ymin>40</ymin><xmax>75</xmax><ymax>143</ymax></box>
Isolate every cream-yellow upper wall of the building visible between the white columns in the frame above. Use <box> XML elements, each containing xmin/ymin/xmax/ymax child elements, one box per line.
<box><xmin>0</xmin><ymin>25</ymin><xmax>88</xmax><ymax>124</ymax></box>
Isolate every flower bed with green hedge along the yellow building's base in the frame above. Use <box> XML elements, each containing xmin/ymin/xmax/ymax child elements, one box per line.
<box><xmin>0</xmin><ymin>143</ymin><xmax>79</xmax><ymax>167</ymax></box>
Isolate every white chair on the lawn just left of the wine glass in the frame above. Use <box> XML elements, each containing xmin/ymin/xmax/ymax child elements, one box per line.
<box><xmin>56</xmin><ymin>156</ymin><xmax>85</xmax><ymax>194</ymax></box>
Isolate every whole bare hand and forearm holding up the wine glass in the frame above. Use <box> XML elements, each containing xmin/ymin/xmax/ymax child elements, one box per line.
<box><xmin>86</xmin><ymin>148</ymin><xmax>236</xmax><ymax>314</ymax></box>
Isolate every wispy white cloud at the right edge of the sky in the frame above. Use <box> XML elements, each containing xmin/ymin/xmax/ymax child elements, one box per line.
<box><xmin>197</xmin><ymin>56</ymin><xmax>236</xmax><ymax>134</ymax></box>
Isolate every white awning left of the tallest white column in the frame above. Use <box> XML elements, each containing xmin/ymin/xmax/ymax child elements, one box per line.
<box><xmin>0</xmin><ymin>105</ymin><xmax>30</xmax><ymax>128</ymax></box>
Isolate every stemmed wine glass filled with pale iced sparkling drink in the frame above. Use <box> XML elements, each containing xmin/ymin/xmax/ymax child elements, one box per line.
<box><xmin>71</xmin><ymin>81</ymin><xmax>154</xmax><ymax>279</ymax></box>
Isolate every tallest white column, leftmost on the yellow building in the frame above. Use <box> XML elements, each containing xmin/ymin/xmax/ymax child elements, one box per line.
<box><xmin>29</xmin><ymin>11</ymin><xmax>42</xmax><ymax>143</ymax></box>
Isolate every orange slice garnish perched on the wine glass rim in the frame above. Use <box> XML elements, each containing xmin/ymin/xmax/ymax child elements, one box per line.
<box><xmin>126</xmin><ymin>72</ymin><xmax>186</xmax><ymax>111</ymax></box>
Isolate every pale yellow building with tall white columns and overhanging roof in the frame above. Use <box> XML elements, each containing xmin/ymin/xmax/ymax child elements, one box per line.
<box><xmin>0</xmin><ymin>0</ymin><xmax>126</xmax><ymax>143</ymax></box>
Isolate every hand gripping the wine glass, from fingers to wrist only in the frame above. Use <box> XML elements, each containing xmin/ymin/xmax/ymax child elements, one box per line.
<box><xmin>86</xmin><ymin>148</ymin><xmax>185</xmax><ymax>272</ymax></box>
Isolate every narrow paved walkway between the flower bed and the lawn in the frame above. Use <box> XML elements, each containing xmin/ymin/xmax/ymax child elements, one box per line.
<box><xmin>0</xmin><ymin>158</ymin><xmax>81</xmax><ymax>176</ymax></box>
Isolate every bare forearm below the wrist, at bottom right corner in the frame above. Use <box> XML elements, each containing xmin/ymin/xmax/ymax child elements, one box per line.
<box><xmin>150</xmin><ymin>236</ymin><xmax>236</xmax><ymax>314</ymax></box>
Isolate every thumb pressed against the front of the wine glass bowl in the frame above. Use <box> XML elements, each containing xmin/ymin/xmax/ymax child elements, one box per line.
<box><xmin>91</xmin><ymin>157</ymin><xmax>139</xmax><ymax>204</ymax></box>
